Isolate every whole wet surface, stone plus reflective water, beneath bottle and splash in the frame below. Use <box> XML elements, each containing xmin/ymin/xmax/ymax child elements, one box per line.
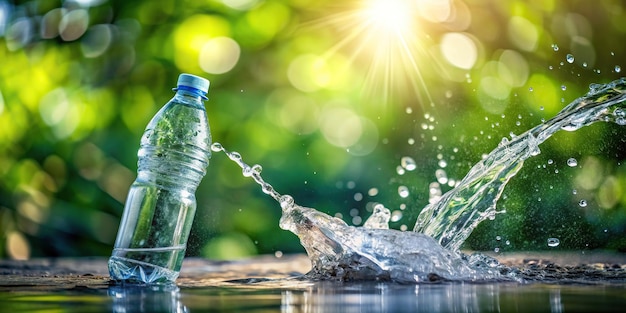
<box><xmin>0</xmin><ymin>254</ymin><xmax>626</xmax><ymax>313</ymax></box>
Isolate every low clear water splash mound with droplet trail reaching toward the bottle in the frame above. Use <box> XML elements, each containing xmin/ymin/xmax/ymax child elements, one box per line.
<box><xmin>211</xmin><ymin>143</ymin><xmax>504</xmax><ymax>283</ymax></box>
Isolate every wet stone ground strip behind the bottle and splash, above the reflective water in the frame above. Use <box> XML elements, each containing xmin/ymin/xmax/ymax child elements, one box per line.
<box><xmin>0</xmin><ymin>252</ymin><xmax>626</xmax><ymax>292</ymax></box>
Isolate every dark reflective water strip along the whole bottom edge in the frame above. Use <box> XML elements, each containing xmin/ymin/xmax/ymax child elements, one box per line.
<box><xmin>0</xmin><ymin>281</ymin><xmax>626</xmax><ymax>313</ymax></box>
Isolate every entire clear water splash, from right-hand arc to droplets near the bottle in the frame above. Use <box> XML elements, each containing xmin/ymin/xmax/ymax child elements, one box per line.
<box><xmin>211</xmin><ymin>78</ymin><xmax>626</xmax><ymax>282</ymax></box>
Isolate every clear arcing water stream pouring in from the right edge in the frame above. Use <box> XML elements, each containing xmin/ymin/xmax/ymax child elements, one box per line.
<box><xmin>414</xmin><ymin>78</ymin><xmax>626</xmax><ymax>250</ymax></box>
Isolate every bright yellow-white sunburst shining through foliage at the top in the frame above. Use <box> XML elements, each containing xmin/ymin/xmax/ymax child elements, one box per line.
<box><xmin>305</xmin><ymin>0</ymin><xmax>432</xmax><ymax>103</ymax></box>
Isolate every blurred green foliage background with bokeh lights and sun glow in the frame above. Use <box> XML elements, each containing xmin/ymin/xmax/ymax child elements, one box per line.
<box><xmin>0</xmin><ymin>0</ymin><xmax>626</xmax><ymax>258</ymax></box>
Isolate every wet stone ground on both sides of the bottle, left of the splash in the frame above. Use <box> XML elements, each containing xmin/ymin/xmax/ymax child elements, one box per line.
<box><xmin>0</xmin><ymin>255</ymin><xmax>310</xmax><ymax>292</ymax></box>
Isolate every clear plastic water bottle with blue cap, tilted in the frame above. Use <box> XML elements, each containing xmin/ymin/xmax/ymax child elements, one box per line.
<box><xmin>109</xmin><ymin>74</ymin><xmax>211</xmax><ymax>284</ymax></box>
